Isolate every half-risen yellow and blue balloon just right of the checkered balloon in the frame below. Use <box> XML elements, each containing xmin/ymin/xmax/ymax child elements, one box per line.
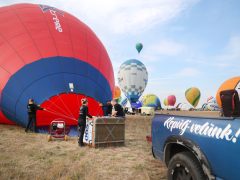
<box><xmin>140</xmin><ymin>94</ymin><xmax>162</xmax><ymax>110</ymax></box>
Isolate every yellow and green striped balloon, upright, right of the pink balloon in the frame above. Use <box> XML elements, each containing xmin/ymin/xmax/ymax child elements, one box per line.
<box><xmin>185</xmin><ymin>87</ymin><xmax>201</xmax><ymax>107</ymax></box>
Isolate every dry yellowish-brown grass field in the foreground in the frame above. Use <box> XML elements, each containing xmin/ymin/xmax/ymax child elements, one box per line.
<box><xmin>0</xmin><ymin>116</ymin><xmax>166</xmax><ymax>180</ymax></box>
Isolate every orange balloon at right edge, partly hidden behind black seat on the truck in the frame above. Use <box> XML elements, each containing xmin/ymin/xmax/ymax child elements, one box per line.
<box><xmin>216</xmin><ymin>76</ymin><xmax>240</xmax><ymax>108</ymax></box>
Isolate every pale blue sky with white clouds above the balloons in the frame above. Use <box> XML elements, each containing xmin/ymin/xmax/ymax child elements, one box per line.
<box><xmin>0</xmin><ymin>0</ymin><xmax>240</xmax><ymax>107</ymax></box>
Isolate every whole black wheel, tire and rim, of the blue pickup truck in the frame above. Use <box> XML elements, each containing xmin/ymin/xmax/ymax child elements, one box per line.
<box><xmin>168</xmin><ymin>152</ymin><xmax>207</xmax><ymax>180</ymax></box>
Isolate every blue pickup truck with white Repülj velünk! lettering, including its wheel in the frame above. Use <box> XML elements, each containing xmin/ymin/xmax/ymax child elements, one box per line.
<box><xmin>152</xmin><ymin>112</ymin><xmax>240</xmax><ymax>180</ymax></box>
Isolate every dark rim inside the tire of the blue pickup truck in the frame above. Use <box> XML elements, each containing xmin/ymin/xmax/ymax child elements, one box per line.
<box><xmin>172</xmin><ymin>164</ymin><xmax>193</xmax><ymax>180</ymax></box>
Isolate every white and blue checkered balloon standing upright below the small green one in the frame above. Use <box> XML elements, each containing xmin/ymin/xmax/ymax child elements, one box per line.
<box><xmin>118</xmin><ymin>59</ymin><xmax>148</xmax><ymax>103</ymax></box>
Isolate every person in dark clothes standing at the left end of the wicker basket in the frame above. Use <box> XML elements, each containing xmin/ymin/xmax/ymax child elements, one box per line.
<box><xmin>78</xmin><ymin>99</ymin><xmax>92</xmax><ymax>147</ymax></box>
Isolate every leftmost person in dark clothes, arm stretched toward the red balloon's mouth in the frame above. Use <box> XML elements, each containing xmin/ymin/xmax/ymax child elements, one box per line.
<box><xmin>25</xmin><ymin>99</ymin><xmax>44</xmax><ymax>132</ymax></box>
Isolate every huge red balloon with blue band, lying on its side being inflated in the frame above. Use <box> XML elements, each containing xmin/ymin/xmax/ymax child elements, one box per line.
<box><xmin>0</xmin><ymin>4</ymin><xmax>114</xmax><ymax>126</ymax></box>
